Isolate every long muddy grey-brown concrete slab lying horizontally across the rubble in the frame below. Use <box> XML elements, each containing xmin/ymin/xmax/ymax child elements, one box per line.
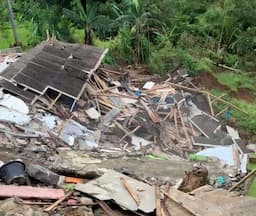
<box><xmin>51</xmin><ymin>151</ymin><xmax>225</xmax><ymax>181</ymax></box>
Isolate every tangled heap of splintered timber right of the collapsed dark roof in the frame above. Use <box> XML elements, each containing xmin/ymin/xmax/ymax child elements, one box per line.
<box><xmin>86</xmin><ymin>68</ymin><xmax>204</xmax><ymax>156</ymax></box>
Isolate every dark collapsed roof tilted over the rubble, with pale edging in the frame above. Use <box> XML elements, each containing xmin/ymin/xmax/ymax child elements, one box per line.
<box><xmin>0</xmin><ymin>41</ymin><xmax>107</xmax><ymax>107</ymax></box>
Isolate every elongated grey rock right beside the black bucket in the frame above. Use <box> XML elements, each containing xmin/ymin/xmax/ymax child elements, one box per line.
<box><xmin>26</xmin><ymin>164</ymin><xmax>62</xmax><ymax>185</ymax></box>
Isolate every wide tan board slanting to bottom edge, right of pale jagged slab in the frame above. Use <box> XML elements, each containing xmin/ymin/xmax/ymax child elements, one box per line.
<box><xmin>162</xmin><ymin>188</ymin><xmax>223</xmax><ymax>216</ymax></box>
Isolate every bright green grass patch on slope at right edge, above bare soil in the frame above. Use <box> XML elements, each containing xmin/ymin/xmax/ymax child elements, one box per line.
<box><xmin>215</xmin><ymin>72</ymin><xmax>256</xmax><ymax>92</ymax></box>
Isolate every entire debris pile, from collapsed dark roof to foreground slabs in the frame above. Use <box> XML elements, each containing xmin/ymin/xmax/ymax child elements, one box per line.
<box><xmin>0</xmin><ymin>41</ymin><xmax>255</xmax><ymax>216</ymax></box>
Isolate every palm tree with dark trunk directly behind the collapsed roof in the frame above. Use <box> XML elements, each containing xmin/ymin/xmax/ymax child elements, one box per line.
<box><xmin>64</xmin><ymin>0</ymin><xmax>109</xmax><ymax>45</ymax></box>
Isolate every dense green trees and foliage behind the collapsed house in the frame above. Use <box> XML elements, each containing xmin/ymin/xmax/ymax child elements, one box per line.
<box><xmin>0</xmin><ymin>0</ymin><xmax>256</xmax><ymax>73</ymax></box>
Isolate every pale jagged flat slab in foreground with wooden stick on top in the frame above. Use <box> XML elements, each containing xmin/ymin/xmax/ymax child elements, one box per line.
<box><xmin>75</xmin><ymin>170</ymin><xmax>155</xmax><ymax>213</ymax></box>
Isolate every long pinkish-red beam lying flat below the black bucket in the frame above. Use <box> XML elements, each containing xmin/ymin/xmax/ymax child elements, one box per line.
<box><xmin>0</xmin><ymin>185</ymin><xmax>65</xmax><ymax>200</ymax></box>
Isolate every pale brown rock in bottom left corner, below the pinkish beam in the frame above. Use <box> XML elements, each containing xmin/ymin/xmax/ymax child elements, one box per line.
<box><xmin>0</xmin><ymin>198</ymin><xmax>48</xmax><ymax>216</ymax></box>
